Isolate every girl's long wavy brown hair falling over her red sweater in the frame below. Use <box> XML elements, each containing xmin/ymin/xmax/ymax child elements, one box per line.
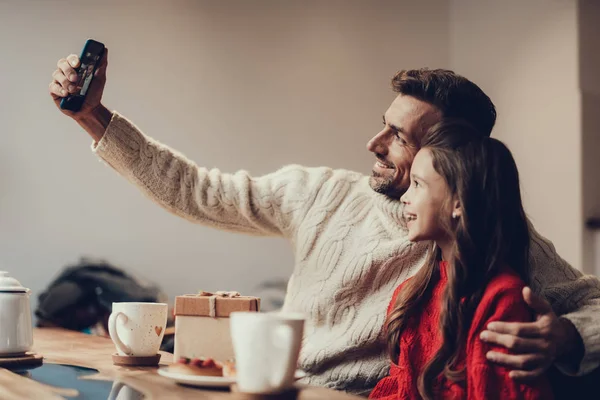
<box><xmin>386</xmin><ymin>121</ymin><xmax>529</xmax><ymax>399</ymax></box>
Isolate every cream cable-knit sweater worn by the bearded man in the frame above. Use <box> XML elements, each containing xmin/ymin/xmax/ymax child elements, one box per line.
<box><xmin>93</xmin><ymin>112</ymin><xmax>600</xmax><ymax>394</ymax></box>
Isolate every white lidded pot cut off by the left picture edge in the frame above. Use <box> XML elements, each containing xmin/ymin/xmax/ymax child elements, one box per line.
<box><xmin>0</xmin><ymin>271</ymin><xmax>33</xmax><ymax>357</ymax></box>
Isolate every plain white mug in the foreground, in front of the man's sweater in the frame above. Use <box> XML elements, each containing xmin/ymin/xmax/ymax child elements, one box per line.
<box><xmin>230</xmin><ymin>312</ymin><xmax>304</xmax><ymax>394</ymax></box>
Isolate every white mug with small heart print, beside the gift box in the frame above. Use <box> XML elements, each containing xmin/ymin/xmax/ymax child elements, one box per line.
<box><xmin>108</xmin><ymin>303</ymin><xmax>168</xmax><ymax>357</ymax></box>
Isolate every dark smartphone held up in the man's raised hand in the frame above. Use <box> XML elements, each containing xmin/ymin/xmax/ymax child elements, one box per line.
<box><xmin>60</xmin><ymin>39</ymin><xmax>104</xmax><ymax>112</ymax></box>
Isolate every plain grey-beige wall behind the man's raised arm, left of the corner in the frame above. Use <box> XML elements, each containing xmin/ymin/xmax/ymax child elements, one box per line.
<box><xmin>0</xmin><ymin>0</ymin><xmax>449</xmax><ymax>308</ymax></box>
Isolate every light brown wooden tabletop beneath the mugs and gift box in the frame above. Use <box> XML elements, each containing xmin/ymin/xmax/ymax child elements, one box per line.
<box><xmin>0</xmin><ymin>328</ymin><xmax>361</xmax><ymax>400</ymax></box>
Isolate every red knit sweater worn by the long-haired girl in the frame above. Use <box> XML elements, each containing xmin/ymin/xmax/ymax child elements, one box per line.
<box><xmin>369</xmin><ymin>262</ymin><xmax>553</xmax><ymax>400</ymax></box>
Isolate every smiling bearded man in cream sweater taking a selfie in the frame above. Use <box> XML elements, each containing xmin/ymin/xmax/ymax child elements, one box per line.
<box><xmin>50</xmin><ymin>51</ymin><xmax>600</xmax><ymax>393</ymax></box>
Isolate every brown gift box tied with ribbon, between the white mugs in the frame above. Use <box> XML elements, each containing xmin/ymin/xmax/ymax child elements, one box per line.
<box><xmin>174</xmin><ymin>292</ymin><xmax>260</xmax><ymax>361</ymax></box>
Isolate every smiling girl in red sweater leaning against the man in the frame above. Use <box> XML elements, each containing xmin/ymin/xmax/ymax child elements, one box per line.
<box><xmin>370</xmin><ymin>122</ymin><xmax>552</xmax><ymax>400</ymax></box>
